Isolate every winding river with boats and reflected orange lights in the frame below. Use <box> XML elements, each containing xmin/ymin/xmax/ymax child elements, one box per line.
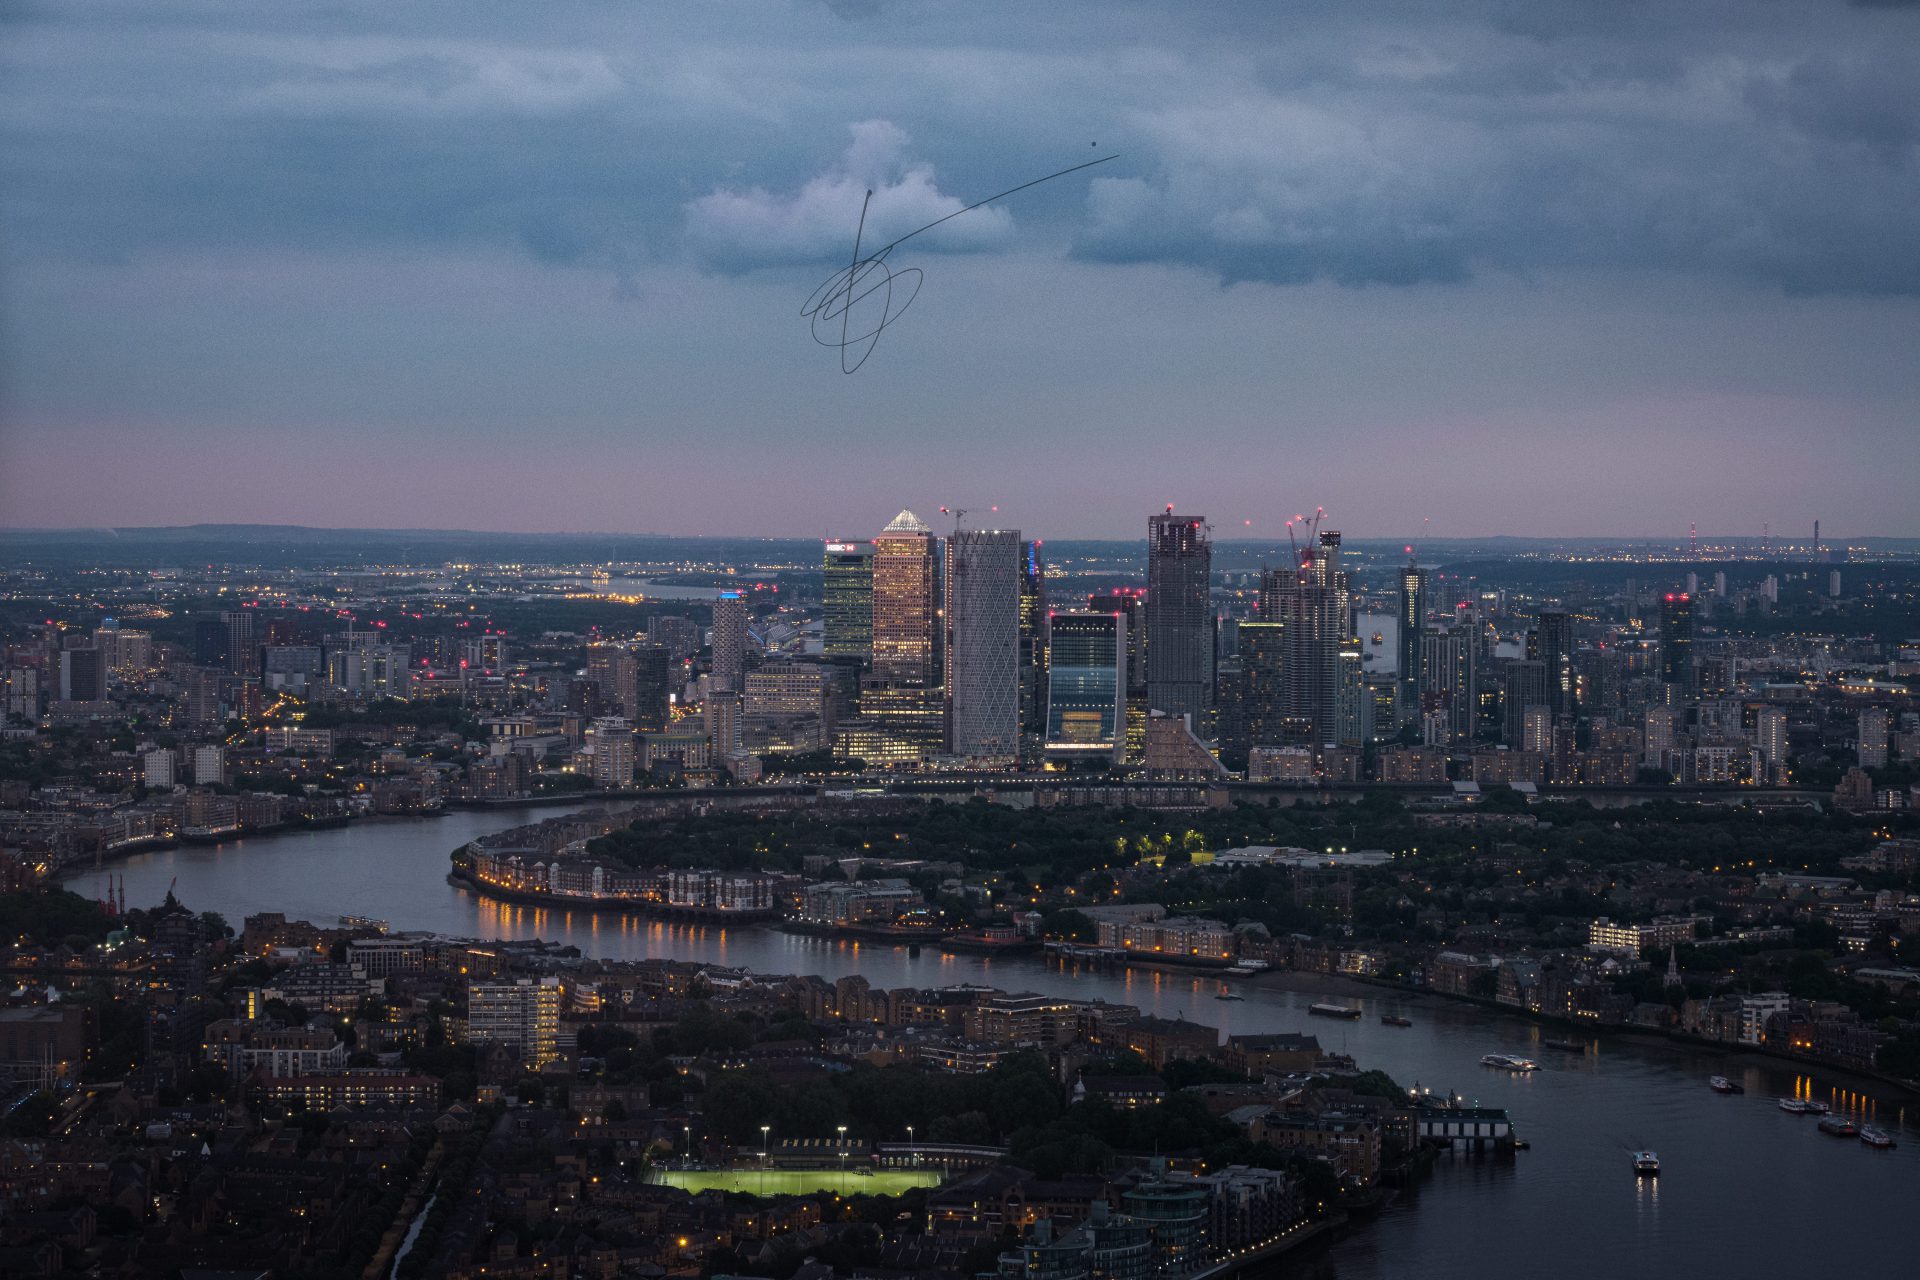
<box><xmin>65</xmin><ymin>810</ymin><xmax>1920</xmax><ymax>1280</ymax></box>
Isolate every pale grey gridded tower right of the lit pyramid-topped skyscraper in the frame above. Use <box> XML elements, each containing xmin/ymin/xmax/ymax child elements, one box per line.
<box><xmin>945</xmin><ymin>530</ymin><xmax>1021</xmax><ymax>766</ymax></box>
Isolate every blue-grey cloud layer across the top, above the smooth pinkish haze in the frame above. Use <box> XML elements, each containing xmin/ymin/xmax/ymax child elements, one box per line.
<box><xmin>0</xmin><ymin>0</ymin><xmax>1920</xmax><ymax>292</ymax></box>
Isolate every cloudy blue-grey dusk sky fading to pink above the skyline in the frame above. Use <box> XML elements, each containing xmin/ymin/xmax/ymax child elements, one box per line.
<box><xmin>0</xmin><ymin>0</ymin><xmax>1920</xmax><ymax>537</ymax></box>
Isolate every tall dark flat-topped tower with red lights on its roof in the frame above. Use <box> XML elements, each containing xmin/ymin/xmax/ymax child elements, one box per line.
<box><xmin>1146</xmin><ymin>507</ymin><xmax>1213</xmax><ymax>737</ymax></box>
